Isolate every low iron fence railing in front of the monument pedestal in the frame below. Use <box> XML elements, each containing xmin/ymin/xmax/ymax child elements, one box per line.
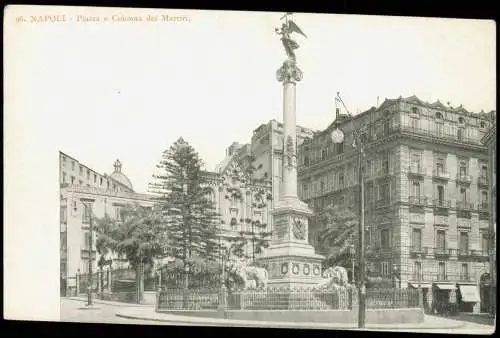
<box><xmin>157</xmin><ymin>288</ymin><xmax>423</xmax><ymax>311</ymax></box>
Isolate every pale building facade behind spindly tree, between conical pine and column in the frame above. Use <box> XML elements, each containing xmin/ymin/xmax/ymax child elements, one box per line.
<box><xmin>211</xmin><ymin>143</ymin><xmax>272</xmax><ymax>257</ymax></box>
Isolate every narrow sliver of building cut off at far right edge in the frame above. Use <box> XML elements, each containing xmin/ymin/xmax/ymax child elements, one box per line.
<box><xmin>481</xmin><ymin>123</ymin><xmax>497</xmax><ymax>313</ymax></box>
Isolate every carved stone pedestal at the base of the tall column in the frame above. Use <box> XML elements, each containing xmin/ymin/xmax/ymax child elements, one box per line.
<box><xmin>259</xmin><ymin>198</ymin><xmax>324</xmax><ymax>289</ymax></box>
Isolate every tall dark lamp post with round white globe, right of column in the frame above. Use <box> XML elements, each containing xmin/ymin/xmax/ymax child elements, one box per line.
<box><xmin>331</xmin><ymin>115</ymin><xmax>366</xmax><ymax>328</ymax></box>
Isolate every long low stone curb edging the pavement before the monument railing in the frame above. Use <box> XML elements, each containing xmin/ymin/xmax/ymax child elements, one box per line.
<box><xmin>115</xmin><ymin>312</ymin><xmax>466</xmax><ymax>331</ymax></box>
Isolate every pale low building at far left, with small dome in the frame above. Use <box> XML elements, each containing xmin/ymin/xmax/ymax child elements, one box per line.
<box><xmin>59</xmin><ymin>152</ymin><xmax>153</xmax><ymax>287</ymax></box>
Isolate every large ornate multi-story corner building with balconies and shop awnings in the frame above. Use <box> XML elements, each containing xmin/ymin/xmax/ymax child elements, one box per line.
<box><xmin>298</xmin><ymin>96</ymin><xmax>490</xmax><ymax>311</ymax></box>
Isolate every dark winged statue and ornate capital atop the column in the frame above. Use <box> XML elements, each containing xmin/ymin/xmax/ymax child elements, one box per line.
<box><xmin>275</xmin><ymin>13</ymin><xmax>307</xmax><ymax>82</ymax></box>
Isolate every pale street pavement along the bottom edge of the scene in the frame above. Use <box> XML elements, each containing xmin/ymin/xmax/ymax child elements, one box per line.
<box><xmin>61</xmin><ymin>298</ymin><xmax>494</xmax><ymax>335</ymax></box>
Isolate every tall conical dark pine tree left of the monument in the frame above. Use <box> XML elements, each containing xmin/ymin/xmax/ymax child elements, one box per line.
<box><xmin>150</xmin><ymin>138</ymin><xmax>218</xmax><ymax>283</ymax></box>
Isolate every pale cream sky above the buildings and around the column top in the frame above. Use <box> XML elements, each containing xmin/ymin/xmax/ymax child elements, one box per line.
<box><xmin>4</xmin><ymin>9</ymin><xmax>496</xmax><ymax>192</ymax></box>
